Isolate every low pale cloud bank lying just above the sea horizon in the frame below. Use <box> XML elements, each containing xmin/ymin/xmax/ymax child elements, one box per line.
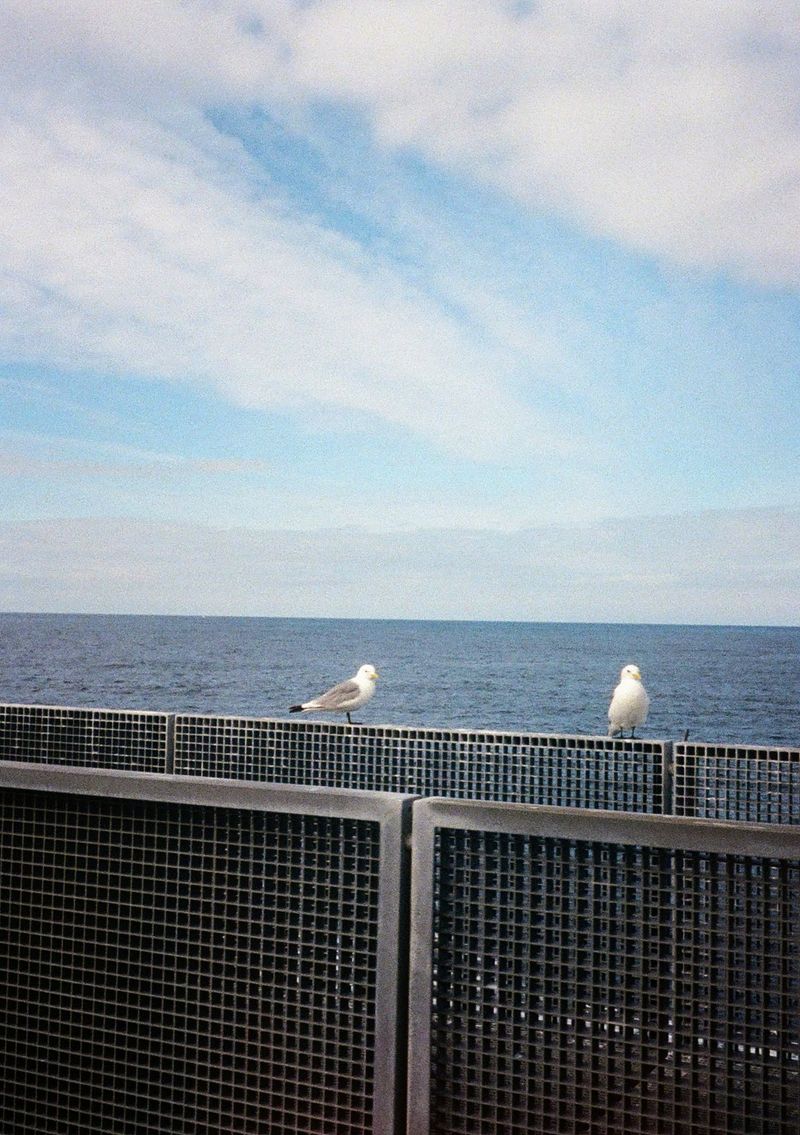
<box><xmin>0</xmin><ymin>510</ymin><xmax>800</xmax><ymax>624</ymax></box>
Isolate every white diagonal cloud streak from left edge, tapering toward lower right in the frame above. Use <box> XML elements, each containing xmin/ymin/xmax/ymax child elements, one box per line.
<box><xmin>0</xmin><ymin>81</ymin><xmax>564</xmax><ymax>459</ymax></box>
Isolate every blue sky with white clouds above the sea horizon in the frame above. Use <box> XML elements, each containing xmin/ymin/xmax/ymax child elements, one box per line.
<box><xmin>0</xmin><ymin>0</ymin><xmax>800</xmax><ymax>624</ymax></box>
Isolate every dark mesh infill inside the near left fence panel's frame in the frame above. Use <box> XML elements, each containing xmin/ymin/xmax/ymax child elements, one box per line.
<box><xmin>0</xmin><ymin>771</ymin><xmax>408</xmax><ymax>1135</ymax></box>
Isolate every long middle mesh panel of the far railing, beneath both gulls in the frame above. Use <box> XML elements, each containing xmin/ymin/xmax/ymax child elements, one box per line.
<box><xmin>175</xmin><ymin>715</ymin><xmax>670</xmax><ymax>813</ymax></box>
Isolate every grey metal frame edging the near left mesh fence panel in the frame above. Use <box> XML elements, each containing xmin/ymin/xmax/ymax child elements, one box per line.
<box><xmin>0</xmin><ymin>760</ymin><xmax>413</xmax><ymax>1135</ymax></box>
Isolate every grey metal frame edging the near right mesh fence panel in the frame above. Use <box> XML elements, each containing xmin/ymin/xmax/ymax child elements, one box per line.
<box><xmin>406</xmin><ymin>798</ymin><xmax>800</xmax><ymax>1135</ymax></box>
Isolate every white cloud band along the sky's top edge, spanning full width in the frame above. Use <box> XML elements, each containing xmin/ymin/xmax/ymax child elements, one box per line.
<box><xmin>6</xmin><ymin>0</ymin><xmax>800</xmax><ymax>285</ymax></box>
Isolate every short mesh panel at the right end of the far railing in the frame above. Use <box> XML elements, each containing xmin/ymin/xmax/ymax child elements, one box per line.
<box><xmin>674</xmin><ymin>741</ymin><xmax>800</xmax><ymax>824</ymax></box>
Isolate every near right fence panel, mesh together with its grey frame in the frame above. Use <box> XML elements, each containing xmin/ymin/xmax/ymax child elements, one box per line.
<box><xmin>409</xmin><ymin>801</ymin><xmax>800</xmax><ymax>1135</ymax></box>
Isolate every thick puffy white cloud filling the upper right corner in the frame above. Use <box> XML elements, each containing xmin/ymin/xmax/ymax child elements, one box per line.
<box><xmin>294</xmin><ymin>0</ymin><xmax>800</xmax><ymax>286</ymax></box>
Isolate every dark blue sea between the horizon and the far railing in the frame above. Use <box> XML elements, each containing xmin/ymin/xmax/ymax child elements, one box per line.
<box><xmin>0</xmin><ymin>614</ymin><xmax>800</xmax><ymax>747</ymax></box>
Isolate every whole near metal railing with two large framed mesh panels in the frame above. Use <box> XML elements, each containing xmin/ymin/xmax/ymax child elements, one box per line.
<box><xmin>0</xmin><ymin>730</ymin><xmax>800</xmax><ymax>1135</ymax></box>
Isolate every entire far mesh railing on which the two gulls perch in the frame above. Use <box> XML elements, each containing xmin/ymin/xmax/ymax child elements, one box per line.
<box><xmin>6</xmin><ymin>705</ymin><xmax>800</xmax><ymax>824</ymax></box>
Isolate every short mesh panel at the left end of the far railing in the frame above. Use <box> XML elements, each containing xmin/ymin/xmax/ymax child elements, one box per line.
<box><xmin>0</xmin><ymin>705</ymin><xmax>172</xmax><ymax>773</ymax></box>
